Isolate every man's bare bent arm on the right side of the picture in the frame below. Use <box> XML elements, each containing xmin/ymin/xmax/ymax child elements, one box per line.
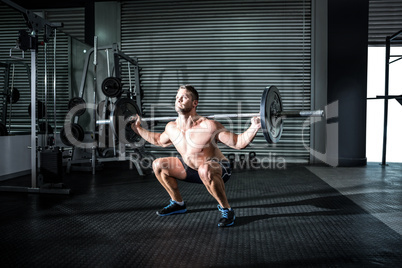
<box><xmin>217</xmin><ymin>117</ymin><xmax>261</xmax><ymax>150</ymax></box>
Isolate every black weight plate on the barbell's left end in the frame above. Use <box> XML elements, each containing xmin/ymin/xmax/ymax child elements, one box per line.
<box><xmin>111</xmin><ymin>98</ymin><xmax>141</xmax><ymax>143</ymax></box>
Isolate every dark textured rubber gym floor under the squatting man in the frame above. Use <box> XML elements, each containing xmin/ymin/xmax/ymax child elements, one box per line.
<box><xmin>0</xmin><ymin>162</ymin><xmax>402</xmax><ymax>267</ymax></box>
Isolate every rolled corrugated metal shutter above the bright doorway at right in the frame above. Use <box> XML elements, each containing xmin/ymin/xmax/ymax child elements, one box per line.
<box><xmin>369</xmin><ymin>0</ymin><xmax>402</xmax><ymax>46</ymax></box>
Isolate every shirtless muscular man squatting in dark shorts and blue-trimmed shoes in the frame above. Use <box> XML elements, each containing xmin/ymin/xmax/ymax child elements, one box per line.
<box><xmin>131</xmin><ymin>85</ymin><xmax>261</xmax><ymax>227</ymax></box>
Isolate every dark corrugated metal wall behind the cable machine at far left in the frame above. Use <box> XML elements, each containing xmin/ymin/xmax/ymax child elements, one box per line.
<box><xmin>0</xmin><ymin>3</ymin><xmax>84</xmax><ymax>133</ymax></box>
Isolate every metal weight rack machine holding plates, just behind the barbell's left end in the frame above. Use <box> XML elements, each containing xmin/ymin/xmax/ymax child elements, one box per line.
<box><xmin>60</xmin><ymin>39</ymin><xmax>152</xmax><ymax>175</ymax></box>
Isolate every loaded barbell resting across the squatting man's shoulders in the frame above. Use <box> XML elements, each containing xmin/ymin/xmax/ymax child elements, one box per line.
<box><xmin>96</xmin><ymin>86</ymin><xmax>324</xmax><ymax>143</ymax></box>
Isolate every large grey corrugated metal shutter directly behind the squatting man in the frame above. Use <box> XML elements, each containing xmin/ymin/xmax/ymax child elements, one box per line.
<box><xmin>121</xmin><ymin>0</ymin><xmax>311</xmax><ymax>163</ymax></box>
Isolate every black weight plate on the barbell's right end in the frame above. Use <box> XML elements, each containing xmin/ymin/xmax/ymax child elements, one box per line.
<box><xmin>260</xmin><ymin>86</ymin><xmax>283</xmax><ymax>143</ymax></box>
